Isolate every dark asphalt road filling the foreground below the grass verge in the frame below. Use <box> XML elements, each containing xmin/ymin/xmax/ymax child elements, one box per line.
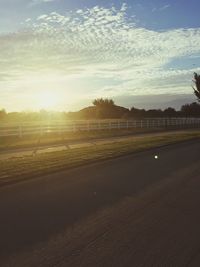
<box><xmin>0</xmin><ymin>141</ymin><xmax>200</xmax><ymax>267</ymax></box>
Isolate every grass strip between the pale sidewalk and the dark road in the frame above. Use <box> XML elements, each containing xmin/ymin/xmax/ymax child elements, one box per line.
<box><xmin>0</xmin><ymin>131</ymin><xmax>200</xmax><ymax>186</ymax></box>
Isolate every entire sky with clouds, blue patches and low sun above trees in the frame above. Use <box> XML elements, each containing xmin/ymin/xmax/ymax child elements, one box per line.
<box><xmin>0</xmin><ymin>0</ymin><xmax>200</xmax><ymax>111</ymax></box>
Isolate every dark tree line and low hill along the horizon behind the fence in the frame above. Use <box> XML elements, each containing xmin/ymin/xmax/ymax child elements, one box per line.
<box><xmin>0</xmin><ymin>73</ymin><xmax>200</xmax><ymax>122</ymax></box>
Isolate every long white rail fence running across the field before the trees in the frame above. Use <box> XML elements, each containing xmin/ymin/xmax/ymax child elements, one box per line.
<box><xmin>0</xmin><ymin>118</ymin><xmax>200</xmax><ymax>137</ymax></box>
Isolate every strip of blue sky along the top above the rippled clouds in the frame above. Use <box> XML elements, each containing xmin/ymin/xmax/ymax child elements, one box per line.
<box><xmin>0</xmin><ymin>0</ymin><xmax>200</xmax><ymax>32</ymax></box>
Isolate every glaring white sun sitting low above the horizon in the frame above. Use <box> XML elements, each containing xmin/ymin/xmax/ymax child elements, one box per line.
<box><xmin>37</xmin><ymin>91</ymin><xmax>59</xmax><ymax>109</ymax></box>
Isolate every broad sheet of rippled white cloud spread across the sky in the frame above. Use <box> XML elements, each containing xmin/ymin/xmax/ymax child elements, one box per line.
<box><xmin>0</xmin><ymin>4</ymin><xmax>200</xmax><ymax>111</ymax></box>
